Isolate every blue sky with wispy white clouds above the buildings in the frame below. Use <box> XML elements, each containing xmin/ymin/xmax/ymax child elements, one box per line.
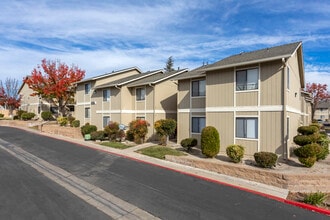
<box><xmin>0</xmin><ymin>0</ymin><xmax>330</xmax><ymax>87</ymax></box>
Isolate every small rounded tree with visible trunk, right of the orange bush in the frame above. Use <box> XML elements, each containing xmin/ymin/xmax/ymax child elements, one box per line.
<box><xmin>154</xmin><ymin>118</ymin><xmax>176</xmax><ymax>146</ymax></box>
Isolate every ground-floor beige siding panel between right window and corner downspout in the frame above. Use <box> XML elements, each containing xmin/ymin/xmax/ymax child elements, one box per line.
<box><xmin>259</xmin><ymin>112</ymin><xmax>284</xmax><ymax>155</ymax></box>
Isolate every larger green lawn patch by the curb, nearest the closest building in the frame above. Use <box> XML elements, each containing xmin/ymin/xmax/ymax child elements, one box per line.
<box><xmin>136</xmin><ymin>145</ymin><xmax>186</xmax><ymax>159</ymax></box>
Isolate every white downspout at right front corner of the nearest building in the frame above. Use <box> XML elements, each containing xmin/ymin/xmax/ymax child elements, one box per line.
<box><xmin>282</xmin><ymin>58</ymin><xmax>289</xmax><ymax>159</ymax></box>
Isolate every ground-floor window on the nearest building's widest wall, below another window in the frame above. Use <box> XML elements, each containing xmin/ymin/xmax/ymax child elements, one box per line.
<box><xmin>236</xmin><ymin>118</ymin><xmax>258</xmax><ymax>139</ymax></box>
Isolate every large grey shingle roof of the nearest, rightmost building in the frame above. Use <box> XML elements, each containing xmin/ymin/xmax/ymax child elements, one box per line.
<box><xmin>206</xmin><ymin>42</ymin><xmax>302</xmax><ymax>71</ymax></box>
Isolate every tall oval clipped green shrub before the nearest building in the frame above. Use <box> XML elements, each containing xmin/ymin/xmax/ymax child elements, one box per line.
<box><xmin>201</xmin><ymin>126</ymin><xmax>220</xmax><ymax>157</ymax></box>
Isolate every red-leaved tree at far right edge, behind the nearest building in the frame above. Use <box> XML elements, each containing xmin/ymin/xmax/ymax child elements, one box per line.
<box><xmin>306</xmin><ymin>83</ymin><xmax>330</xmax><ymax>119</ymax></box>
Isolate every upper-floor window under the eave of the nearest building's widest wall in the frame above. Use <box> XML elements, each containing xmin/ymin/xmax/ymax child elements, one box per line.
<box><xmin>236</xmin><ymin>69</ymin><xmax>259</xmax><ymax>91</ymax></box>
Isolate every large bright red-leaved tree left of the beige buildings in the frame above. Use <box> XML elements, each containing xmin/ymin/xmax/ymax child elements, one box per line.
<box><xmin>24</xmin><ymin>59</ymin><xmax>85</xmax><ymax>116</ymax></box>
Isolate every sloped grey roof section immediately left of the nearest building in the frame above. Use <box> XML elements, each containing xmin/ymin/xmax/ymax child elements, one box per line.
<box><xmin>127</xmin><ymin>69</ymin><xmax>188</xmax><ymax>87</ymax></box>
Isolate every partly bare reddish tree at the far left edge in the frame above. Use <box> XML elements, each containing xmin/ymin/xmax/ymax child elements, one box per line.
<box><xmin>0</xmin><ymin>78</ymin><xmax>21</xmax><ymax>115</ymax></box>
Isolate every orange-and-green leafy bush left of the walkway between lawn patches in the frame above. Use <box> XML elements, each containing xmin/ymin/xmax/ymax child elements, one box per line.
<box><xmin>128</xmin><ymin>119</ymin><xmax>149</xmax><ymax>144</ymax></box>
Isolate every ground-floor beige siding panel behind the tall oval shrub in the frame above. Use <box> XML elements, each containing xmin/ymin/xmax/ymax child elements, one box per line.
<box><xmin>206</xmin><ymin>112</ymin><xmax>235</xmax><ymax>153</ymax></box>
